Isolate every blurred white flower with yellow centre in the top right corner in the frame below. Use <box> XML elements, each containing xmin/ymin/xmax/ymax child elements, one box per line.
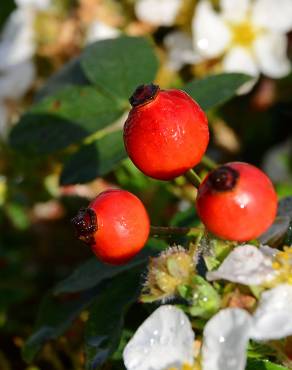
<box><xmin>192</xmin><ymin>0</ymin><xmax>292</xmax><ymax>78</ymax></box>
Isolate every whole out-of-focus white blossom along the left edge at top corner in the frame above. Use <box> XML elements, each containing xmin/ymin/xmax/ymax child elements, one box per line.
<box><xmin>0</xmin><ymin>0</ymin><xmax>51</xmax><ymax>136</ymax></box>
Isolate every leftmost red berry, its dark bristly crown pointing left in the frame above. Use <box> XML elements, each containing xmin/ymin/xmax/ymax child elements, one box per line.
<box><xmin>72</xmin><ymin>189</ymin><xmax>150</xmax><ymax>265</ymax></box>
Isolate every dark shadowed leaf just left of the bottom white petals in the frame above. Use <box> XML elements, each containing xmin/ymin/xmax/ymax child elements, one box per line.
<box><xmin>85</xmin><ymin>270</ymin><xmax>140</xmax><ymax>370</ymax></box>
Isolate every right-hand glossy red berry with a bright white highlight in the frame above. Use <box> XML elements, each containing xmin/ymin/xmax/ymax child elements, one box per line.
<box><xmin>196</xmin><ymin>162</ymin><xmax>277</xmax><ymax>242</ymax></box>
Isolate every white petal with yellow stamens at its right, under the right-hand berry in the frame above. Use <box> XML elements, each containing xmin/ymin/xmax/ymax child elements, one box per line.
<box><xmin>206</xmin><ymin>244</ymin><xmax>292</xmax><ymax>287</ymax></box>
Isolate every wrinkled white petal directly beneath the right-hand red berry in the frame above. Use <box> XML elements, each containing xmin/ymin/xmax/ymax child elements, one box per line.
<box><xmin>207</xmin><ymin>244</ymin><xmax>275</xmax><ymax>285</ymax></box>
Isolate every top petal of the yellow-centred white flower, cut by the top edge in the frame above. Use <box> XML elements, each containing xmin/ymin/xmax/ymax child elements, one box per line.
<box><xmin>220</xmin><ymin>0</ymin><xmax>250</xmax><ymax>23</ymax></box>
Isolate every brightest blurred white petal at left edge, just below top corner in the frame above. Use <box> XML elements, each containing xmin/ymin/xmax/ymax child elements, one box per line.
<box><xmin>0</xmin><ymin>8</ymin><xmax>35</xmax><ymax>70</ymax></box>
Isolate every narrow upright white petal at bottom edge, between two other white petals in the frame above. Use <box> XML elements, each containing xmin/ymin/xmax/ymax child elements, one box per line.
<box><xmin>202</xmin><ymin>308</ymin><xmax>251</xmax><ymax>370</ymax></box>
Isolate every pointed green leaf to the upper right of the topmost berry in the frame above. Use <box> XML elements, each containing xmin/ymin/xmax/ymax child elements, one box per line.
<box><xmin>183</xmin><ymin>73</ymin><xmax>251</xmax><ymax>110</ymax></box>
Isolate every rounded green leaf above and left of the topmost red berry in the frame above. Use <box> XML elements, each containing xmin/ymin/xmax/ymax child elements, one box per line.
<box><xmin>81</xmin><ymin>36</ymin><xmax>158</xmax><ymax>103</ymax></box>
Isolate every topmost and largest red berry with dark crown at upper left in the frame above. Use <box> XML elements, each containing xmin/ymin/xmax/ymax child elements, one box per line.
<box><xmin>124</xmin><ymin>84</ymin><xmax>209</xmax><ymax>180</ymax></box>
